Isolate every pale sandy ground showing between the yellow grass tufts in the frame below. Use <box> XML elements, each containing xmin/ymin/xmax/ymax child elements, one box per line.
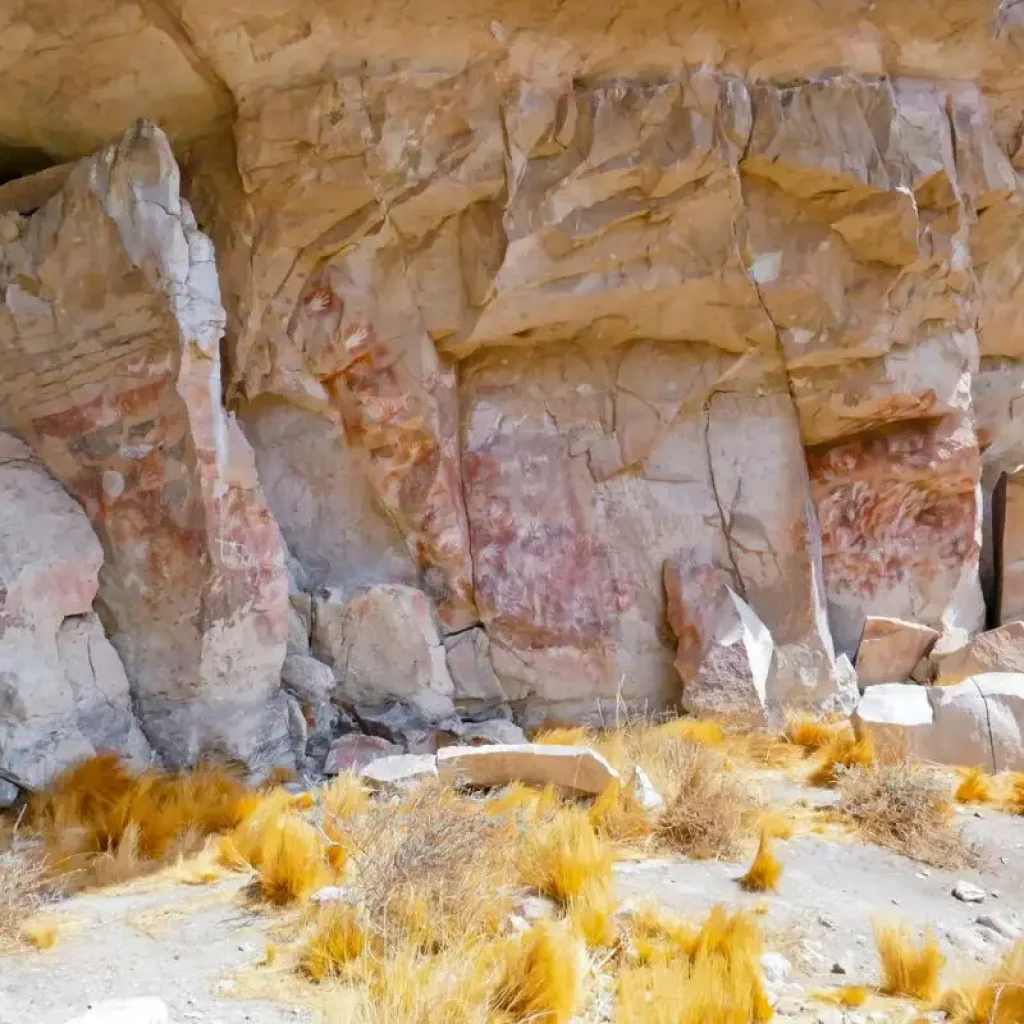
<box><xmin>0</xmin><ymin>776</ymin><xmax>1024</xmax><ymax>1024</ymax></box>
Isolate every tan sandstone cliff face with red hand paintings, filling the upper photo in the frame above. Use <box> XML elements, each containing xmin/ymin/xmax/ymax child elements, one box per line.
<box><xmin>0</xmin><ymin>0</ymin><xmax>1024</xmax><ymax>782</ymax></box>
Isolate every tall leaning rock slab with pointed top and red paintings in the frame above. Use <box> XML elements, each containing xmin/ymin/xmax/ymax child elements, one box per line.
<box><xmin>0</xmin><ymin>122</ymin><xmax>288</xmax><ymax>768</ymax></box>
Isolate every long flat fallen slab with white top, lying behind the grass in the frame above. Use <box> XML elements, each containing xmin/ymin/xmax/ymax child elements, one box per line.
<box><xmin>437</xmin><ymin>743</ymin><xmax>618</xmax><ymax>795</ymax></box>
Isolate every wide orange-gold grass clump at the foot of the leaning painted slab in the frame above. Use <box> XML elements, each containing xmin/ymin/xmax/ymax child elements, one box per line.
<box><xmin>28</xmin><ymin>753</ymin><xmax>259</xmax><ymax>886</ymax></box>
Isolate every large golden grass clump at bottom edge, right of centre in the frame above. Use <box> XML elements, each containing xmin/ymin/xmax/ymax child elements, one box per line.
<box><xmin>616</xmin><ymin>906</ymin><xmax>772</xmax><ymax>1024</ymax></box>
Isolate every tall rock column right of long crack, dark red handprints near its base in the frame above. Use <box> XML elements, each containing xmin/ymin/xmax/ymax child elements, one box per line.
<box><xmin>742</xmin><ymin>76</ymin><xmax>983</xmax><ymax>656</ymax></box>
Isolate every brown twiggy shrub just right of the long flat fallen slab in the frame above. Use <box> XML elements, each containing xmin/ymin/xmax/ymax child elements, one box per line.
<box><xmin>656</xmin><ymin>741</ymin><xmax>757</xmax><ymax>859</ymax></box>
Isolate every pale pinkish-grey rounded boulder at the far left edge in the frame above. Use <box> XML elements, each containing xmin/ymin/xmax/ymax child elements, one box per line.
<box><xmin>0</xmin><ymin>433</ymin><xmax>150</xmax><ymax>786</ymax></box>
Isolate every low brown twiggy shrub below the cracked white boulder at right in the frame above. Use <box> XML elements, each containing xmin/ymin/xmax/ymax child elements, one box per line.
<box><xmin>839</xmin><ymin>762</ymin><xmax>977</xmax><ymax>867</ymax></box>
